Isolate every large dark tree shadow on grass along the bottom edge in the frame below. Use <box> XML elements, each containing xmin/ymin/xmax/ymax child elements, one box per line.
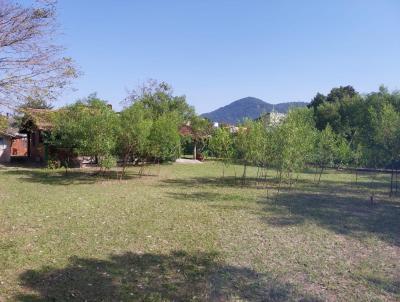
<box><xmin>15</xmin><ymin>251</ymin><xmax>319</xmax><ymax>302</ymax></box>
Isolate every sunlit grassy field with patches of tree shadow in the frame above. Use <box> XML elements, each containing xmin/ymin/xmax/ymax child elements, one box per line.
<box><xmin>0</xmin><ymin>163</ymin><xmax>400</xmax><ymax>301</ymax></box>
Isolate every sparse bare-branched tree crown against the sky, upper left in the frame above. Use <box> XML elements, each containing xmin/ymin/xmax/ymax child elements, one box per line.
<box><xmin>0</xmin><ymin>0</ymin><xmax>77</xmax><ymax>109</ymax></box>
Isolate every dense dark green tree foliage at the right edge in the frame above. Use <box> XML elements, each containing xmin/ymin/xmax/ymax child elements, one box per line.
<box><xmin>310</xmin><ymin>86</ymin><xmax>400</xmax><ymax>167</ymax></box>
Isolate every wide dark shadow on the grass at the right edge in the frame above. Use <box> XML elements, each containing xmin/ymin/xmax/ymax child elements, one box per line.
<box><xmin>265</xmin><ymin>191</ymin><xmax>400</xmax><ymax>245</ymax></box>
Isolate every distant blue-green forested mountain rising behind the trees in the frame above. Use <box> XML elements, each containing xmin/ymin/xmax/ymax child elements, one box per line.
<box><xmin>202</xmin><ymin>97</ymin><xmax>308</xmax><ymax>124</ymax></box>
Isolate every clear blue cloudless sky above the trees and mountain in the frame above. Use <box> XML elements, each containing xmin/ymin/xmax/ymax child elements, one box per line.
<box><xmin>52</xmin><ymin>0</ymin><xmax>400</xmax><ymax>113</ymax></box>
